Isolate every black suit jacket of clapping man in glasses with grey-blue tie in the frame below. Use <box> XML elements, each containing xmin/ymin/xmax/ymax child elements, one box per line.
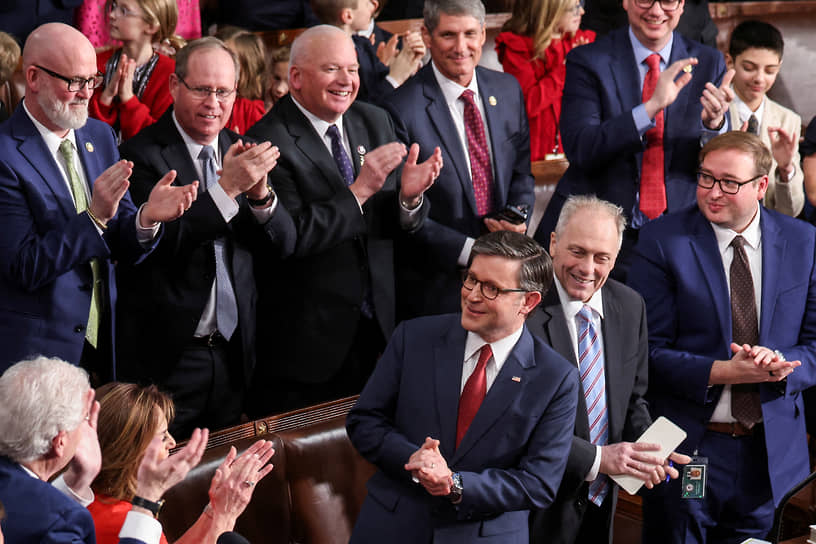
<box><xmin>117</xmin><ymin>108</ymin><xmax>295</xmax><ymax>383</ymax></box>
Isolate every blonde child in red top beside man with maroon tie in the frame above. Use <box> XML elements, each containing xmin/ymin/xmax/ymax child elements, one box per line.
<box><xmin>496</xmin><ymin>0</ymin><xmax>595</xmax><ymax>161</ymax></box>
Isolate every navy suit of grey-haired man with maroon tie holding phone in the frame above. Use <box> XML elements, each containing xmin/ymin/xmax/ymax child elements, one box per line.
<box><xmin>385</xmin><ymin>64</ymin><xmax>535</xmax><ymax>318</ymax></box>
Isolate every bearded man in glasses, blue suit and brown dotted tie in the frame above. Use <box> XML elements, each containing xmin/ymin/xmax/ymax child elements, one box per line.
<box><xmin>629</xmin><ymin>131</ymin><xmax>816</xmax><ymax>544</ymax></box>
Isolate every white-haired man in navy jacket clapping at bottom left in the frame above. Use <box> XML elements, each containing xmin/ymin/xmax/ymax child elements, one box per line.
<box><xmin>0</xmin><ymin>357</ymin><xmax>208</xmax><ymax>544</ymax></box>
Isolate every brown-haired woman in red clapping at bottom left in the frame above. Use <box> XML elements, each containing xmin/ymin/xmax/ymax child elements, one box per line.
<box><xmin>88</xmin><ymin>382</ymin><xmax>275</xmax><ymax>544</ymax></box>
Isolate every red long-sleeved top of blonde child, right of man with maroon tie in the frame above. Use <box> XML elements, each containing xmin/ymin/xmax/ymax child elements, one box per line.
<box><xmin>496</xmin><ymin>30</ymin><xmax>595</xmax><ymax>161</ymax></box>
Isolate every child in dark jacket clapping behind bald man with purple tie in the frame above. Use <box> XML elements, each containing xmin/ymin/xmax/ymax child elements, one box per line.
<box><xmin>312</xmin><ymin>0</ymin><xmax>425</xmax><ymax>105</ymax></box>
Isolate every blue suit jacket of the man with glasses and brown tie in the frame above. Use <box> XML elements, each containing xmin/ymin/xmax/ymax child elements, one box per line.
<box><xmin>628</xmin><ymin>207</ymin><xmax>816</xmax><ymax>504</ymax></box>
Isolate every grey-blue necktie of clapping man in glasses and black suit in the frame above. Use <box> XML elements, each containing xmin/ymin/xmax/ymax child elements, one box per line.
<box><xmin>198</xmin><ymin>145</ymin><xmax>238</xmax><ymax>340</ymax></box>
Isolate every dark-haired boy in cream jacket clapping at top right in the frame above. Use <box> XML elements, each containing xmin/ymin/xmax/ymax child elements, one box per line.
<box><xmin>726</xmin><ymin>21</ymin><xmax>805</xmax><ymax>217</ymax></box>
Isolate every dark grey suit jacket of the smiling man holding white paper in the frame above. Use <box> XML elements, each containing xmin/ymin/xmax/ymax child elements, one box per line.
<box><xmin>527</xmin><ymin>279</ymin><xmax>652</xmax><ymax>544</ymax></box>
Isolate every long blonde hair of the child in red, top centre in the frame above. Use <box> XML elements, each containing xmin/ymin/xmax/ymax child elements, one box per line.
<box><xmin>502</xmin><ymin>0</ymin><xmax>574</xmax><ymax>58</ymax></box>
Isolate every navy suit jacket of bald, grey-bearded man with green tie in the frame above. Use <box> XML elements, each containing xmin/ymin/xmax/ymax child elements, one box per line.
<box><xmin>0</xmin><ymin>105</ymin><xmax>155</xmax><ymax>373</ymax></box>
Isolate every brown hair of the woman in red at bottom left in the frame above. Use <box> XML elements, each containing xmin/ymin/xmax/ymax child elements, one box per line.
<box><xmin>91</xmin><ymin>382</ymin><xmax>174</xmax><ymax>501</ymax></box>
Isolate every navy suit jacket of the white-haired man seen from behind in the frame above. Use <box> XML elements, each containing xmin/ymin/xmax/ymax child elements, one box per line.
<box><xmin>0</xmin><ymin>457</ymin><xmax>142</xmax><ymax>544</ymax></box>
